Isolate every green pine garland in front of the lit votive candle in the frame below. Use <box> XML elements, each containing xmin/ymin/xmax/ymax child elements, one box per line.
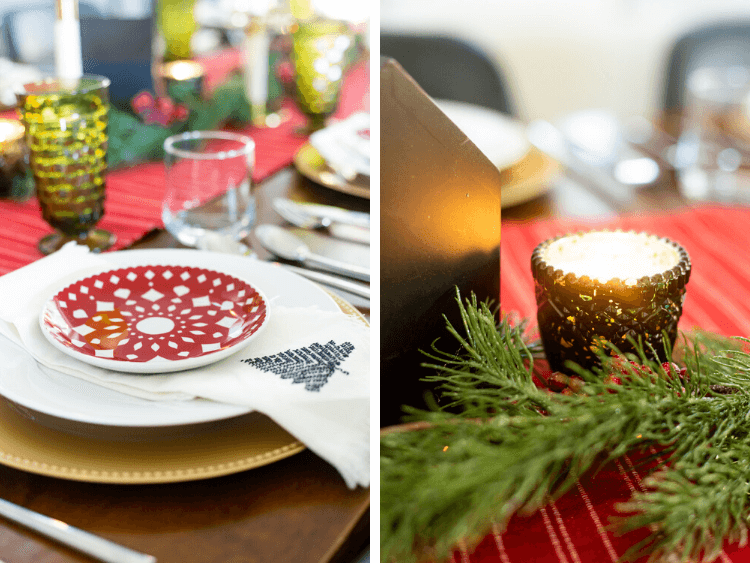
<box><xmin>380</xmin><ymin>290</ymin><xmax>750</xmax><ymax>563</ymax></box>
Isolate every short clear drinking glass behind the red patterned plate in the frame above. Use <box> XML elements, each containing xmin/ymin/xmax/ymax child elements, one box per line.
<box><xmin>162</xmin><ymin>131</ymin><xmax>255</xmax><ymax>246</ymax></box>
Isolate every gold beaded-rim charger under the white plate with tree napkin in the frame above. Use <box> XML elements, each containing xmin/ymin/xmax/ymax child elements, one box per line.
<box><xmin>0</xmin><ymin>294</ymin><xmax>366</xmax><ymax>484</ymax></box>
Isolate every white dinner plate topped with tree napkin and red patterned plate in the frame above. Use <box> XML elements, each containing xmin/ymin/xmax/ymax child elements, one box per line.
<box><xmin>0</xmin><ymin>244</ymin><xmax>369</xmax><ymax>487</ymax></box>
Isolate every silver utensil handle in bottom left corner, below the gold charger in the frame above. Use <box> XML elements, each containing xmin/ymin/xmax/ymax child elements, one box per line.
<box><xmin>0</xmin><ymin>499</ymin><xmax>156</xmax><ymax>563</ymax></box>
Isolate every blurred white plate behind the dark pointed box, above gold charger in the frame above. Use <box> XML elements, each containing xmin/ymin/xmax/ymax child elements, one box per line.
<box><xmin>435</xmin><ymin>100</ymin><xmax>531</xmax><ymax>170</ymax></box>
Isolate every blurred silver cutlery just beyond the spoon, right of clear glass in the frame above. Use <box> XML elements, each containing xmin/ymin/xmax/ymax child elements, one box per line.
<box><xmin>273</xmin><ymin>198</ymin><xmax>370</xmax><ymax>244</ymax></box>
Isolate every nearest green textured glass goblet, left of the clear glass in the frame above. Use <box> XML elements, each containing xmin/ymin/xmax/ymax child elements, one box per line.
<box><xmin>17</xmin><ymin>75</ymin><xmax>115</xmax><ymax>254</ymax></box>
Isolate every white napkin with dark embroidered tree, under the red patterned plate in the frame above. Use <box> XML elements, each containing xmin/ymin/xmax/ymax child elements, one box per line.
<box><xmin>0</xmin><ymin>243</ymin><xmax>370</xmax><ymax>488</ymax></box>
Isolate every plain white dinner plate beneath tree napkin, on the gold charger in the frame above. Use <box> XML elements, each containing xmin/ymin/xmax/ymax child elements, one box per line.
<box><xmin>0</xmin><ymin>249</ymin><xmax>340</xmax><ymax>428</ymax></box>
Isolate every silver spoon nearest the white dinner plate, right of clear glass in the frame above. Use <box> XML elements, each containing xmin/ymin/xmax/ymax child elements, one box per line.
<box><xmin>255</xmin><ymin>225</ymin><xmax>370</xmax><ymax>282</ymax></box>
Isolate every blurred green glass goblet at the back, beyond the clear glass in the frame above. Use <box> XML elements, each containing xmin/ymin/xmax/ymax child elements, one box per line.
<box><xmin>292</xmin><ymin>18</ymin><xmax>352</xmax><ymax>133</ymax></box>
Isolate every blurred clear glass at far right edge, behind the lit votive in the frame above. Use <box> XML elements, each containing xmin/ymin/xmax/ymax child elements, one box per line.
<box><xmin>675</xmin><ymin>66</ymin><xmax>750</xmax><ymax>203</ymax></box>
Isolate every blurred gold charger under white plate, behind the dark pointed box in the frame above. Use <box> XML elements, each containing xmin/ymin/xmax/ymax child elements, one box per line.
<box><xmin>500</xmin><ymin>147</ymin><xmax>560</xmax><ymax>207</ymax></box>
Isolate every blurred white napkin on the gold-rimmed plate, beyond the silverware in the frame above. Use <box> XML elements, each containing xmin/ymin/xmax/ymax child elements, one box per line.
<box><xmin>310</xmin><ymin>112</ymin><xmax>370</xmax><ymax>180</ymax></box>
